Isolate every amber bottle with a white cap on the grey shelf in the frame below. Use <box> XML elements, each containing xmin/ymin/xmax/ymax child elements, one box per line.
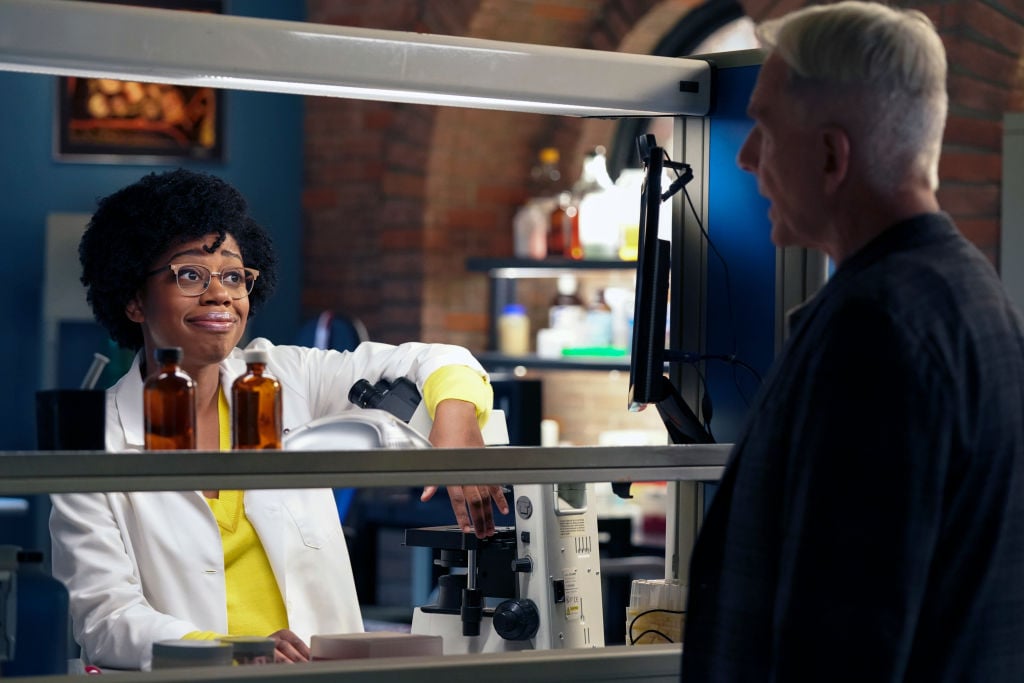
<box><xmin>231</xmin><ymin>348</ymin><xmax>284</xmax><ymax>449</ymax></box>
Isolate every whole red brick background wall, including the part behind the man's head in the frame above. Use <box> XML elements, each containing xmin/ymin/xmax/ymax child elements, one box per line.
<box><xmin>302</xmin><ymin>0</ymin><xmax>1024</xmax><ymax>442</ymax></box>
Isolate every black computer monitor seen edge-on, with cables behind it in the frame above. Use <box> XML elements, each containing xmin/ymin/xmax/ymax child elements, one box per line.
<box><xmin>629</xmin><ymin>133</ymin><xmax>714</xmax><ymax>443</ymax></box>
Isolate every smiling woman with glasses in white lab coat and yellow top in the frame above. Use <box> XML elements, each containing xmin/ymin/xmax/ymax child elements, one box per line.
<box><xmin>50</xmin><ymin>170</ymin><xmax>508</xmax><ymax>669</ymax></box>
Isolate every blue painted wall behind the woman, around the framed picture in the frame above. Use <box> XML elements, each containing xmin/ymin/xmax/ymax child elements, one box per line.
<box><xmin>0</xmin><ymin>0</ymin><xmax>305</xmax><ymax>451</ymax></box>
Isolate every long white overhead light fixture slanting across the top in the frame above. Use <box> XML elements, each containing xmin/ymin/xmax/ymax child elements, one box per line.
<box><xmin>0</xmin><ymin>0</ymin><xmax>711</xmax><ymax>117</ymax></box>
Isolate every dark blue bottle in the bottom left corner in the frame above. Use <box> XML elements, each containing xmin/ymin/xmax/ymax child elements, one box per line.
<box><xmin>0</xmin><ymin>550</ymin><xmax>69</xmax><ymax>676</ymax></box>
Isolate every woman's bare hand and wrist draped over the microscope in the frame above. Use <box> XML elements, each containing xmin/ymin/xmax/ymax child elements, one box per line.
<box><xmin>420</xmin><ymin>398</ymin><xmax>509</xmax><ymax>539</ymax></box>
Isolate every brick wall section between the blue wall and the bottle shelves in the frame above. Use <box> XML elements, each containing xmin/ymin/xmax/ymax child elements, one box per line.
<box><xmin>302</xmin><ymin>0</ymin><xmax>667</xmax><ymax>349</ymax></box>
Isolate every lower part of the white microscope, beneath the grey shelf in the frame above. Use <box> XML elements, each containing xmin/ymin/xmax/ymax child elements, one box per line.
<box><xmin>406</xmin><ymin>483</ymin><xmax>604</xmax><ymax>654</ymax></box>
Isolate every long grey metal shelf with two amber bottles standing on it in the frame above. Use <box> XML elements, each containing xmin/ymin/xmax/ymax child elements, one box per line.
<box><xmin>0</xmin><ymin>444</ymin><xmax>730</xmax><ymax>496</ymax></box>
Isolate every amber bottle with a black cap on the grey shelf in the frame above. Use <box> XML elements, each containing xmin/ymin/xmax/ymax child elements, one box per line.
<box><xmin>142</xmin><ymin>346</ymin><xmax>196</xmax><ymax>451</ymax></box>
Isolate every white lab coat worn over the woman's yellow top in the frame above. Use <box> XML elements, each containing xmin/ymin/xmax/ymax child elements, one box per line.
<box><xmin>50</xmin><ymin>339</ymin><xmax>484</xmax><ymax>669</ymax></box>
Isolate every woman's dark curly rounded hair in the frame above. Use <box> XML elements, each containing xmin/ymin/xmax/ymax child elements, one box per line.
<box><xmin>78</xmin><ymin>169</ymin><xmax>278</xmax><ymax>350</ymax></box>
